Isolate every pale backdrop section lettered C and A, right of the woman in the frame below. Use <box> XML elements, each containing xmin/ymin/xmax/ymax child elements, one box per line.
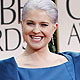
<box><xmin>57</xmin><ymin>0</ymin><xmax>80</xmax><ymax>52</ymax></box>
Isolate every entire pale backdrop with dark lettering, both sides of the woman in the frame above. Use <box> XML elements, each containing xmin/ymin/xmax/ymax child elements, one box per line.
<box><xmin>0</xmin><ymin>0</ymin><xmax>80</xmax><ymax>59</ymax></box>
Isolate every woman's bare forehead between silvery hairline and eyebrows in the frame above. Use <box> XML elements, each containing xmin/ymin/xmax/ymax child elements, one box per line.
<box><xmin>25</xmin><ymin>9</ymin><xmax>52</xmax><ymax>22</ymax></box>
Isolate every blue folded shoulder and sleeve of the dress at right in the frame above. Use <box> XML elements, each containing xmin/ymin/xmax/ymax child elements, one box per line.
<box><xmin>60</xmin><ymin>52</ymin><xmax>80</xmax><ymax>80</ymax></box>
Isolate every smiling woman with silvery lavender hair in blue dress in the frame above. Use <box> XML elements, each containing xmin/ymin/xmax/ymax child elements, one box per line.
<box><xmin>0</xmin><ymin>0</ymin><xmax>80</xmax><ymax>80</ymax></box>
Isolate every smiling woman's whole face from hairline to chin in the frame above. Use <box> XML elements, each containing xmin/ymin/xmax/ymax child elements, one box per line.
<box><xmin>22</xmin><ymin>10</ymin><xmax>56</xmax><ymax>50</ymax></box>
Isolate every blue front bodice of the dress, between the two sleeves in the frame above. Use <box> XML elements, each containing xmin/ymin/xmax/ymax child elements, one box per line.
<box><xmin>19</xmin><ymin>64</ymin><xmax>75</xmax><ymax>80</ymax></box>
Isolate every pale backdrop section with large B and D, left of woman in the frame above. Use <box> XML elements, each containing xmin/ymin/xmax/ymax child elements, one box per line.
<box><xmin>0</xmin><ymin>0</ymin><xmax>27</xmax><ymax>59</ymax></box>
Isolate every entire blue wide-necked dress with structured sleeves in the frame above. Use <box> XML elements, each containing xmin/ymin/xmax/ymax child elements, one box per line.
<box><xmin>0</xmin><ymin>52</ymin><xmax>80</xmax><ymax>80</ymax></box>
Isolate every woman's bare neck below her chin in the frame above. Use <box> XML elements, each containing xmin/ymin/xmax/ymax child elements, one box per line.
<box><xmin>24</xmin><ymin>46</ymin><xmax>50</xmax><ymax>58</ymax></box>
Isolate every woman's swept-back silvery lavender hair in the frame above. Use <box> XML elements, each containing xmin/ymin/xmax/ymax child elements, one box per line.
<box><xmin>22</xmin><ymin>0</ymin><xmax>58</xmax><ymax>24</ymax></box>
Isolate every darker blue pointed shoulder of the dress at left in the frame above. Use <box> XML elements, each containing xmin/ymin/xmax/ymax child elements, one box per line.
<box><xmin>0</xmin><ymin>57</ymin><xmax>17</xmax><ymax>80</ymax></box>
